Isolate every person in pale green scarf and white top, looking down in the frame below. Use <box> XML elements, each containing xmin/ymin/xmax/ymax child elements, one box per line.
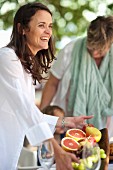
<box><xmin>40</xmin><ymin>16</ymin><xmax>113</xmax><ymax>137</ymax></box>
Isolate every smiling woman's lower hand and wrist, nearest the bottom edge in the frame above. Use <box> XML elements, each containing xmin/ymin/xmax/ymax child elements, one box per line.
<box><xmin>52</xmin><ymin>139</ymin><xmax>80</xmax><ymax>170</ymax></box>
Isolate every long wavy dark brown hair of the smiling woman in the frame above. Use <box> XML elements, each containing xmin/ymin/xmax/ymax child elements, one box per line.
<box><xmin>7</xmin><ymin>2</ymin><xmax>55</xmax><ymax>82</ymax></box>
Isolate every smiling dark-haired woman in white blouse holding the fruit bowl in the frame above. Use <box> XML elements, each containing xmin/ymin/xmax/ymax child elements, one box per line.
<box><xmin>0</xmin><ymin>3</ymin><xmax>93</xmax><ymax>170</ymax></box>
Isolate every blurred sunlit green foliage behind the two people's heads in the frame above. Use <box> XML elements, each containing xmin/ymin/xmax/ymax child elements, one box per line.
<box><xmin>0</xmin><ymin>0</ymin><xmax>113</xmax><ymax>51</ymax></box>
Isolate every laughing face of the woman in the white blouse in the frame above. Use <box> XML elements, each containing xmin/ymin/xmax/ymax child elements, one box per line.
<box><xmin>24</xmin><ymin>10</ymin><xmax>52</xmax><ymax>55</ymax></box>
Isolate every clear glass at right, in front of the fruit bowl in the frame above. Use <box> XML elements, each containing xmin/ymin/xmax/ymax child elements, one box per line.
<box><xmin>82</xmin><ymin>142</ymin><xmax>101</xmax><ymax>170</ymax></box>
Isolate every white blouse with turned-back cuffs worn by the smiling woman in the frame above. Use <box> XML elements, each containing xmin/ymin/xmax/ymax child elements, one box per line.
<box><xmin>0</xmin><ymin>47</ymin><xmax>58</xmax><ymax>170</ymax></box>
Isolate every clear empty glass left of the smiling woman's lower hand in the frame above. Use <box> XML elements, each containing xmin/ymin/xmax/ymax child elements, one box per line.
<box><xmin>38</xmin><ymin>140</ymin><xmax>54</xmax><ymax>170</ymax></box>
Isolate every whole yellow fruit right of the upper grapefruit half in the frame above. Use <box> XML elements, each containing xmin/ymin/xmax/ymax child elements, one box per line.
<box><xmin>86</xmin><ymin>126</ymin><xmax>102</xmax><ymax>142</ymax></box>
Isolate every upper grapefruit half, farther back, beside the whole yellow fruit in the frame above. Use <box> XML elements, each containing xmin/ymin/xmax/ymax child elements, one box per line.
<box><xmin>66</xmin><ymin>129</ymin><xmax>86</xmax><ymax>141</ymax></box>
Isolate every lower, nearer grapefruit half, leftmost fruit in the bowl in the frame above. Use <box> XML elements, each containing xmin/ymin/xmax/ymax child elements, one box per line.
<box><xmin>61</xmin><ymin>137</ymin><xmax>80</xmax><ymax>151</ymax></box>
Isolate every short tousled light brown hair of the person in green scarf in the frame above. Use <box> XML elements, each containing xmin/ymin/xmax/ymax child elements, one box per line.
<box><xmin>87</xmin><ymin>16</ymin><xmax>113</xmax><ymax>50</ymax></box>
